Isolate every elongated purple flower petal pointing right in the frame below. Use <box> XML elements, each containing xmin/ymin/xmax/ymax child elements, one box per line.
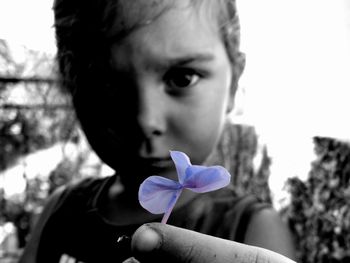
<box><xmin>183</xmin><ymin>165</ymin><xmax>231</xmax><ymax>193</ymax></box>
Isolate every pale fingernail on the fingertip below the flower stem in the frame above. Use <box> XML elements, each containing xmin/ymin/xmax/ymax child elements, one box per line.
<box><xmin>131</xmin><ymin>225</ymin><xmax>161</xmax><ymax>252</ymax></box>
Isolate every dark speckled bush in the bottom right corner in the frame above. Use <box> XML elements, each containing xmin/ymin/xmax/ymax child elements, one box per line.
<box><xmin>282</xmin><ymin>137</ymin><xmax>350</xmax><ymax>263</ymax></box>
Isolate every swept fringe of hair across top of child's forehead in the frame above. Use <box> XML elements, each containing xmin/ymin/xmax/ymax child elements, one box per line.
<box><xmin>104</xmin><ymin>0</ymin><xmax>218</xmax><ymax>40</ymax></box>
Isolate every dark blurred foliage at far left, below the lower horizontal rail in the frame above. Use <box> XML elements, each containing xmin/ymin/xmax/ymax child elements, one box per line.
<box><xmin>0</xmin><ymin>106</ymin><xmax>77</xmax><ymax>171</ymax></box>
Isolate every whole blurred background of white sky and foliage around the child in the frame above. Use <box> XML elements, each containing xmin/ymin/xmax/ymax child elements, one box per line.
<box><xmin>0</xmin><ymin>0</ymin><xmax>350</xmax><ymax>262</ymax></box>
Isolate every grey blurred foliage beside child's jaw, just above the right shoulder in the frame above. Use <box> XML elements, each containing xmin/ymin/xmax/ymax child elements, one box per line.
<box><xmin>210</xmin><ymin>124</ymin><xmax>272</xmax><ymax>203</ymax></box>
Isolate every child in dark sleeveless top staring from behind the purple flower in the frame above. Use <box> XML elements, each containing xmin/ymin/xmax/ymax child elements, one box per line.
<box><xmin>21</xmin><ymin>0</ymin><xmax>293</xmax><ymax>262</ymax></box>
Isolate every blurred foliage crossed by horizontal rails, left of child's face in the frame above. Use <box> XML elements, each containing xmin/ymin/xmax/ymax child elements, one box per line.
<box><xmin>0</xmin><ymin>40</ymin><xmax>75</xmax><ymax>172</ymax></box>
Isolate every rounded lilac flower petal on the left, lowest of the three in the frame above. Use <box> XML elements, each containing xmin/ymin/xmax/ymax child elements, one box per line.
<box><xmin>139</xmin><ymin>176</ymin><xmax>182</xmax><ymax>214</ymax></box>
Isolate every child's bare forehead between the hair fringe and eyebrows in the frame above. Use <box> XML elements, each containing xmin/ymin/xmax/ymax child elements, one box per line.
<box><xmin>109</xmin><ymin>1</ymin><xmax>230</xmax><ymax>75</ymax></box>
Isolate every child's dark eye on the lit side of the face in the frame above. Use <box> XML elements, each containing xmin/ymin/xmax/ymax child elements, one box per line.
<box><xmin>164</xmin><ymin>68</ymin><xmax>200</xmax><ymax>89</ymax></box>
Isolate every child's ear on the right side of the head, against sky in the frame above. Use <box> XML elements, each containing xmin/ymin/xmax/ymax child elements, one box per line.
<box><xmin>227</xmin><ymin>52</ymin><xmax>245</xmax><ymax>113</ymax></box>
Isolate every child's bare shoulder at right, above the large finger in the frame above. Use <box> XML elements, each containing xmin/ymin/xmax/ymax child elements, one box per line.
<box><xmin>244</xmin><ymin>208</ymin><xmax>295</xmax><ymax>259</ymax></box>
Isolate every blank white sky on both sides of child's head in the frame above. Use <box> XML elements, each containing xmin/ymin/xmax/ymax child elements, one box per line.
<box><xmin>0</xmin><ymin>0</ymin><xmax>350</xmax><ymax>206</ymax></box>
